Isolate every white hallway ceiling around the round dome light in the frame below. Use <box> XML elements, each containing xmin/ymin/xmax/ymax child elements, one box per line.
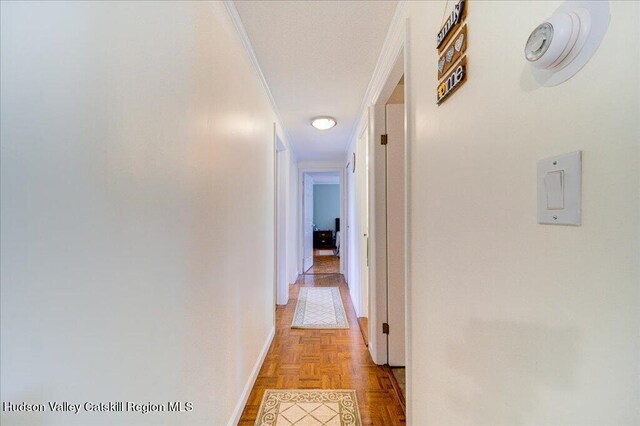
<box><xmin>235</xmin><ymin>1</ymin><xmax>397</xmax><ymax>161</ymax></box>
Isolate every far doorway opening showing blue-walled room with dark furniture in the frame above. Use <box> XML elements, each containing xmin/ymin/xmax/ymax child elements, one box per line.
<box><xmin>302</xmin><ymin>171</ymin><xmax>342</xmax><ymax>275</ymax></box>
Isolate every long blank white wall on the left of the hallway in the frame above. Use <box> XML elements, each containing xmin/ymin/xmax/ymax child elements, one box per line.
<box><xmin>1</xmin><ymin>2</ymin><xmax>275</xmax><ymax>425</ymax></box>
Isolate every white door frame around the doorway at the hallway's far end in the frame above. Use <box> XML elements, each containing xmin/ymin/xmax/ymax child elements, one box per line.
<box><xmin>298</xmin><ymin>162</ymin><xmax>348</xmax><ymax>274</ymax></box>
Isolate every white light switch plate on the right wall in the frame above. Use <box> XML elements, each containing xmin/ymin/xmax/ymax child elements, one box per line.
<box><xmin>538</xmin><ymin>151</ymin><xmax>582</xmax><ymax>226</ymax></box>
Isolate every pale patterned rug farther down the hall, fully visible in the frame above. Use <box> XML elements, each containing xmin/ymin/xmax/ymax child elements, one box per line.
<box><xmin>291</xmin><ymin>287</ymin><xmax>349</xmax><ymax>328</ymax></box>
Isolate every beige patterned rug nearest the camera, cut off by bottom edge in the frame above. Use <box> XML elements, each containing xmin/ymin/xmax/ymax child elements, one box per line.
<box><xmin>256</xmin><ymin>389</ymin><xmax>361</xmax><ymax>426</ymax></box>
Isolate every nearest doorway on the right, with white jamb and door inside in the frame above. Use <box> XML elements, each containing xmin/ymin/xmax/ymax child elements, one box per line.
<box><xmin>367</xmin><ymin>44</ymin><xmax>411</xmax><ymax>412</ymax></box>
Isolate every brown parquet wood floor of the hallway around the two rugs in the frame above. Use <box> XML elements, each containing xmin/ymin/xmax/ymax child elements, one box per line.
<box><xmin>238</xmin><ymin>274</ymin><xmax>405</xmax><ymax>426</ymax></box>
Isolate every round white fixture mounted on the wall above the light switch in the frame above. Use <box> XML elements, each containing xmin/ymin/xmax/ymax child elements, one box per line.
<box><xmin>524</xmin><ymin>0</ymin><xmax>610</xmax><ymax>86</ymax></box>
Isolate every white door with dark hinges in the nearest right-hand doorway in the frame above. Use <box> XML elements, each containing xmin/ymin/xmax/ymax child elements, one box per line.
<box><xmin>386</xmin><ymin>104</ymin><xmax>405</xmax><ymax>367</ymax></box>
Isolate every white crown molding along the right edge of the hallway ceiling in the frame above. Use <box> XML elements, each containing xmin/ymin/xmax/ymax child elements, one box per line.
<box><xmin>344</xmin><ymin>0</ymin><xmax>407</xmax><ymax>161</ymax></box>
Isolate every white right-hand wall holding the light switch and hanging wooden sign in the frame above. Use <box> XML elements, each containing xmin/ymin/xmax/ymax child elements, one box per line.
<box><xmin>407</xmin><ymin>1</ymin><xmax>640</xmax><ymax>426</ymax></box>
